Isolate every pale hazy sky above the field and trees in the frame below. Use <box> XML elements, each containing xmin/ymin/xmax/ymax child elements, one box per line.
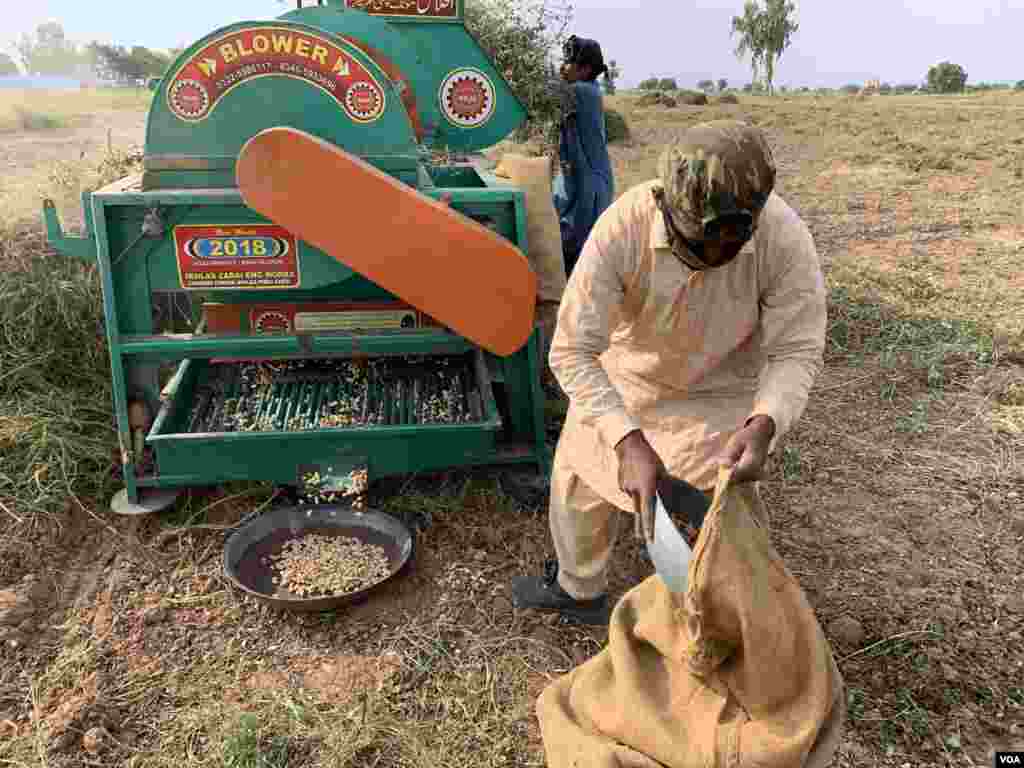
<box><xmin>0</xmin><ymin>0</ymin><xmax>1024</xmax><ymax>87</ymax></box>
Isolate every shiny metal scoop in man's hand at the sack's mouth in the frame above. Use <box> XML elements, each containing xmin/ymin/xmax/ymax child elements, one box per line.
<box><xmin>646</xmin><ymin>477</ymin><xmax>711</xmax><ymax>593</ymax></box>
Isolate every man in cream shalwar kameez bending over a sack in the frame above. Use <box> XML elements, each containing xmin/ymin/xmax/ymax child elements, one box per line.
<box><xmin>513</xmin><ymin>121</ymin><xmax>826</xmax><ymax>624</ymax></box>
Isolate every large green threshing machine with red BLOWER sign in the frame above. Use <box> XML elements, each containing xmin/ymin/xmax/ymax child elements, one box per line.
<box><xmin>44</xmin><ymin>0</ymin><xmax>550</xmax><ymax>514</ymax></box>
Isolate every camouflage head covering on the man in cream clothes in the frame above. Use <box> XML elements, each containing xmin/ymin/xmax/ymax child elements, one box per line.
<box><xmin>654</xmin><ymin>120</ymin><xmax>775</xmax><ymax>269</ymax></box>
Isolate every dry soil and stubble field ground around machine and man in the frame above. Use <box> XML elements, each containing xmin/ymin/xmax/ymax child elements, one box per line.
<box><xmin>0</xmin><ymin>90</ymin><xmax>1024</xmax><ymax>768</ymax></box>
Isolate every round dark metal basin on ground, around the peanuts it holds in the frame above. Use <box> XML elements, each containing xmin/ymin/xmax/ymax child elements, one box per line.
<box><xmin>224</xmin><ymin>506</ymin><xmax>413</xmax><ymax>611</ymax></box>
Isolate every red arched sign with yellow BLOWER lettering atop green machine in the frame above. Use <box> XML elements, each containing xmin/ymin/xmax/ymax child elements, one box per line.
<box><xmin>167</xmin><ymin>27</ymin><xmax>385</xmax><ymax>123</ymax></box>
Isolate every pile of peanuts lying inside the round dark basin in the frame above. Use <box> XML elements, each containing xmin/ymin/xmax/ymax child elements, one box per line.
<box><xmin>269</xmin><ymin>534</ymin><xmax>391</xmax><ymax>597</ymax></box>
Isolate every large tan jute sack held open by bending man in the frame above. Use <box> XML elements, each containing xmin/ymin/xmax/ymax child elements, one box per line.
<box><xmin>537</xmin><ymin>470</ymin><xmax>846</xmax><ymax>768</ymax></box>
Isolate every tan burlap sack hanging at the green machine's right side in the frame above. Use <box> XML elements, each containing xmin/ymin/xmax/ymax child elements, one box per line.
<box><xmin>495</xmin><ymin>154</ymin><xmax>565</xmax><ymax>303</ymax></box>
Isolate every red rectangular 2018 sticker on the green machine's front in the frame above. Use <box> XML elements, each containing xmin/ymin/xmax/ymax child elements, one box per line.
<box><xmin>174</xmin><ymin>224</ymin><xmax>300</xmax><ymax>291</ymax></box>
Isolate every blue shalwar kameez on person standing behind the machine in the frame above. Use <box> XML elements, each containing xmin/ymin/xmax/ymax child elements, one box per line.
<box><xmin>554</xmin><ymin>81</ymin><xmax>614</xmax><ymax>275</ymax></box>
